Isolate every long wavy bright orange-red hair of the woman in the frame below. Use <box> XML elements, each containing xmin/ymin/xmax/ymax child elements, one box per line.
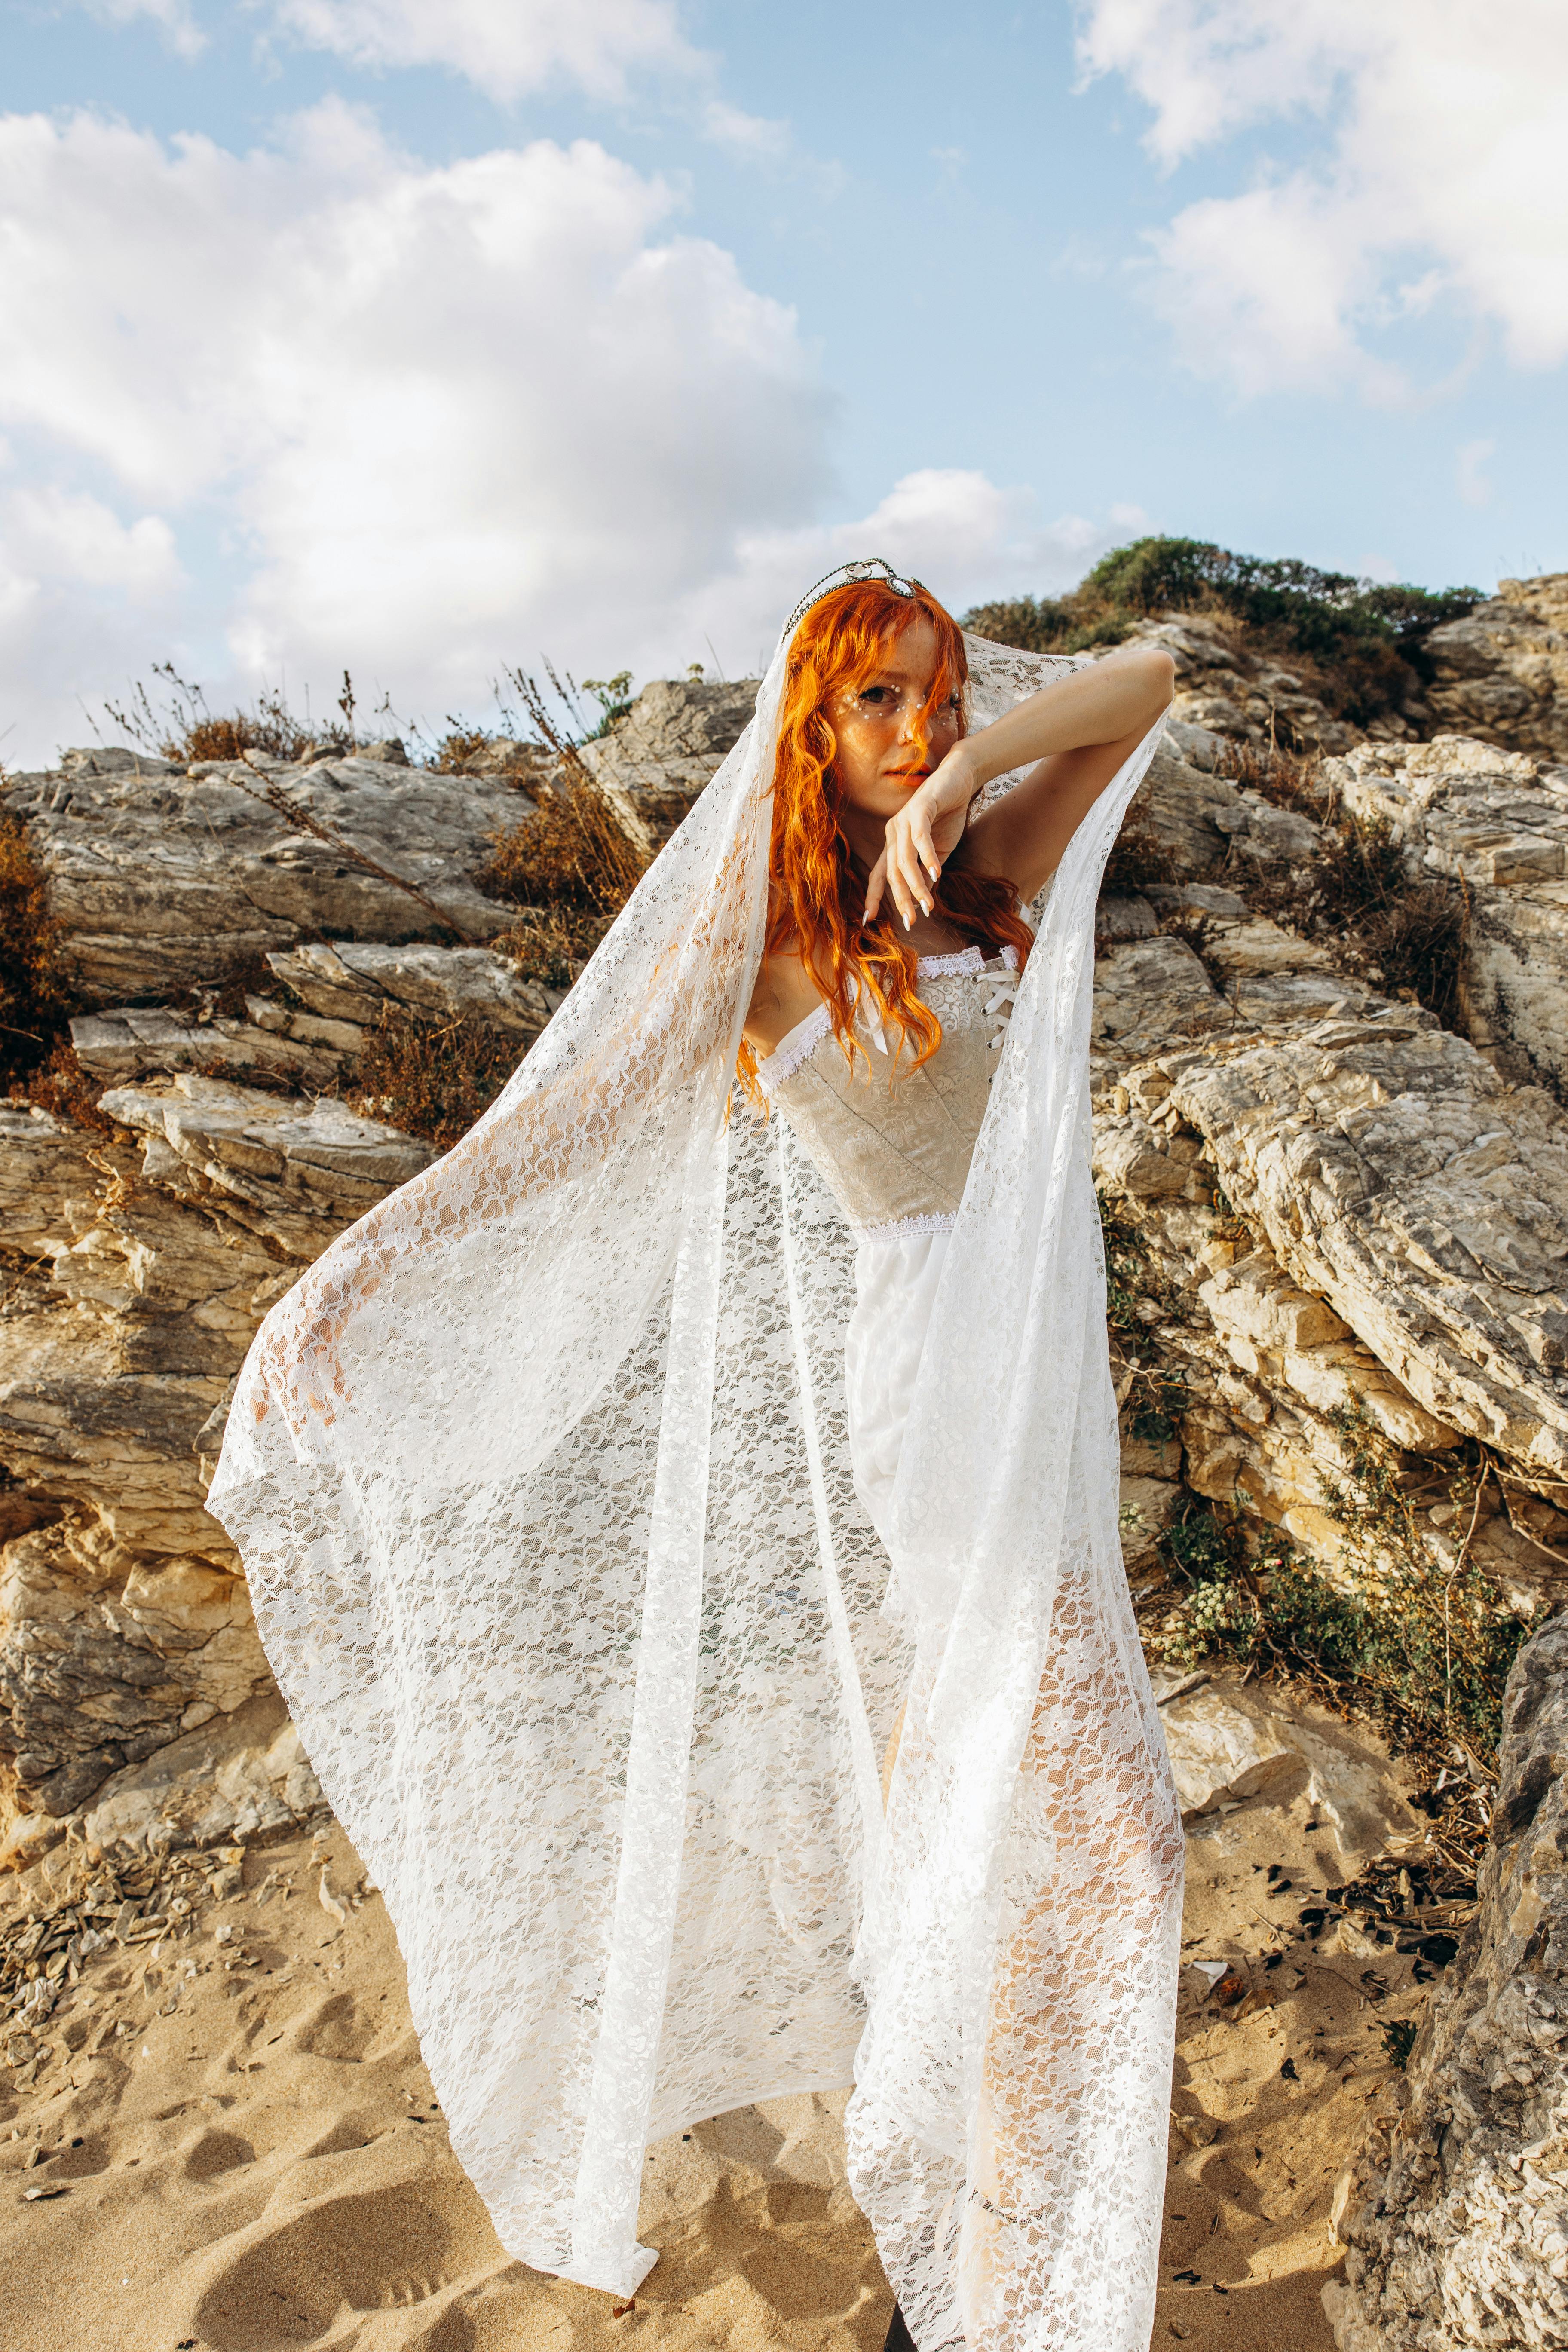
<box><xmin>741</xmin><ymin>581</ymin><xmax>1034</xmax><ymax>1101</ymax></box>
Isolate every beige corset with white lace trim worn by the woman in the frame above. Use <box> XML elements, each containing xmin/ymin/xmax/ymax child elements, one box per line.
<box><xmin>757</xmin><ymin>948</ymin><xmax>1018</xmax><ymax>1237</ymax></box>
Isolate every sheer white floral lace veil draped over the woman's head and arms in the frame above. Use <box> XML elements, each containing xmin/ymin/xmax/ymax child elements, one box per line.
<box><xmin>211</xmin><ymin>579</ymin><xmax>1180</xmax><ymax>2352</ymax></box>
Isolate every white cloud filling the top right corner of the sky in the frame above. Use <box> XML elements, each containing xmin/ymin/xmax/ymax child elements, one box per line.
<box><xmin>1079</xmin><ymin>0</ymin><xmax>1568</xmax><ymax>400</ymax></box>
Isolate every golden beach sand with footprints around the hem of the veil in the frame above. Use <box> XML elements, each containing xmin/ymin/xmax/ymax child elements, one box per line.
<box><xmin>0</xmin><ymin>1768</ymin><xmax>1422</xmax><ymax>2352</ymax></box>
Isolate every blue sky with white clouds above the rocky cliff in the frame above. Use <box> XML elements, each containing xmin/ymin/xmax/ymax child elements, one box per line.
<box><xmin>0</xmin><ymin>0</ymin><xmax>1568</xmax><ymax>762</ymax></box>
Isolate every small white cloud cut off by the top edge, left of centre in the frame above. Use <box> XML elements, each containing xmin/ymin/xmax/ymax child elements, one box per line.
<box><xmin>273</xmin><ymin>0</ymin><xmax>701</xmax><ymax>101</ymax></box>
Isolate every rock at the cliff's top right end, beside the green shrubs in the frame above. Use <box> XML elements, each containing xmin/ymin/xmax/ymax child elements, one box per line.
<box><xmin>1422</xmin><ymin>572</ymin><xmax>1568</xmax><ymax>760</ymax></box>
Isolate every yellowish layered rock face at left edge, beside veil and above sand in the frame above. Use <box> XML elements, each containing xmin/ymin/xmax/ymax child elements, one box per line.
<box><xmin>0</xmin><ymin>1077</ymin><xmax>432</xmax><ymax>1858</ymax></box>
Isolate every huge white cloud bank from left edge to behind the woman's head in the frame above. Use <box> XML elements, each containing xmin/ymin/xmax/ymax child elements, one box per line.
<box><xmin>0</xmin><ymin>101</ymin><xmax>1140</xmax><ymax>760</ymax></box>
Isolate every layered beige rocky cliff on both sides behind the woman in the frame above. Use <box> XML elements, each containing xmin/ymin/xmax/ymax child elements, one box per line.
<box><xmin>0</xmin><ymin>592</ymin><xmax>1568</xmax><ymax>2352</ymax></box>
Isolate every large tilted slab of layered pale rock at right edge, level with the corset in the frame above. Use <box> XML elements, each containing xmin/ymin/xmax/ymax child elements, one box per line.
<box><xmin>1128</xmin><ymin>1025</ymin><xmax>1568</xmax><ymax>1475</ymax></box>
